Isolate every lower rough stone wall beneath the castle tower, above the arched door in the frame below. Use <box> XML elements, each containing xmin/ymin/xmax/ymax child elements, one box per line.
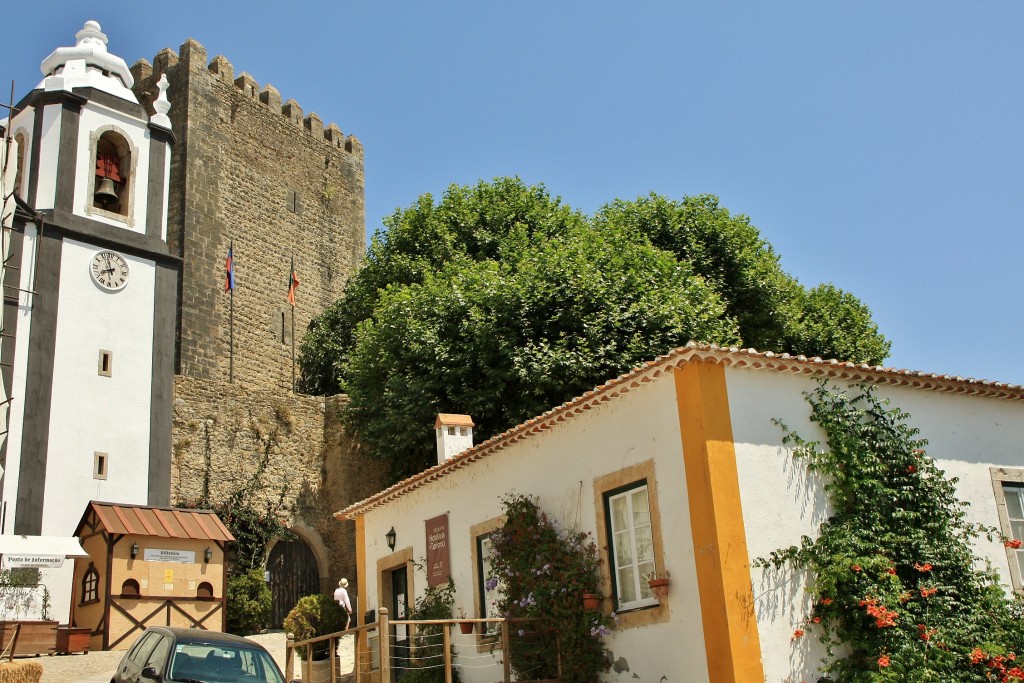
<box><xmin>171</xmin><ymin>376</ymin><xmax>386</xmax><ymax>592</ymax></box>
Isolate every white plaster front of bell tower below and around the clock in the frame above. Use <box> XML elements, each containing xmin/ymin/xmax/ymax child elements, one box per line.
<box><xmin>42</xmin><ymin>240</ymin><xmax>156</xmax><ymax>536</ymax></box>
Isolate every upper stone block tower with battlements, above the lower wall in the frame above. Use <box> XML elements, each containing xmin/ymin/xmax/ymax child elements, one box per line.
<box><xmin>132</xmin><ymin>40</ymin><xmax>366</xmax><ymax>391</ymax></box>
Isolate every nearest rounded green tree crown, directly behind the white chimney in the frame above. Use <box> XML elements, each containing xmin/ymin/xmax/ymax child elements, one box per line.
<box><xmin>342</xmin><ymin>214</ymin><xmax>738</xmax><ymax>476</ymax></box>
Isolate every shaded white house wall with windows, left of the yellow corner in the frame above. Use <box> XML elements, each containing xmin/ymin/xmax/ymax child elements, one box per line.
<box><xmin>360</xmin><ymin>376</ymin><xmax>708</xmax><ymax>683</ymax></box>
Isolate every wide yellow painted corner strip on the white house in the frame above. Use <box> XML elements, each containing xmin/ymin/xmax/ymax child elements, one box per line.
<box><xmin>674</xmin><ymin>360</ymin><xmax>764</xmax><ymax>683</ymax></box>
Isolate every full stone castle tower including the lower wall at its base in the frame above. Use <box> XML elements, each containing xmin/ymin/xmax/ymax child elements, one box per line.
<box><xmin>131</xmin><ymin>39</ymin><xmax>383</xmax><ymax>624</ymax></box>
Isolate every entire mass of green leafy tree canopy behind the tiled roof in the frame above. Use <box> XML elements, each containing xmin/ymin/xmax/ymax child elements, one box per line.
<box><xmin>300</xmin><ymin>178</ymin><xmax>889</xmax><ymax>476</ymax></box>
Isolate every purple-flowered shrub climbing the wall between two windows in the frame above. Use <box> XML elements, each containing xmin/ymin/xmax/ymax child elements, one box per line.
<box><xmin>488</xmin><ymin>494</ymin><xmax>614</xmax><ymax>683</ymax></box>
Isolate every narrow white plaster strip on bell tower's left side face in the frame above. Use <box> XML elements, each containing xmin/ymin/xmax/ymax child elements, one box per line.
<box><xmin>0</xmin><ymin>223</ymin><xmax>39</xmax><ymax>533</ymax></box>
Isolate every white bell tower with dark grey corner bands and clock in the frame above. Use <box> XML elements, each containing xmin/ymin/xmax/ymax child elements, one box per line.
<box><xmin>0</xmin><ymin>22</ymin><xmax>180</xmax><ymax>620</ymax></box>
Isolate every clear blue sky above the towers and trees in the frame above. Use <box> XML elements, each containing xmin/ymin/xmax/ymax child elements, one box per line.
<box><xmin>0</xmin><ymin>0</ymin><xmax>1024</xmax><ymax>384</ymax></box>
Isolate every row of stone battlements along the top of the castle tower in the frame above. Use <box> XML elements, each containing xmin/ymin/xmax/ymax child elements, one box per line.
<box><xmin>130</xmin><ymin>38</ymin><xmax>362</xmax><ymax>159</ymax></box>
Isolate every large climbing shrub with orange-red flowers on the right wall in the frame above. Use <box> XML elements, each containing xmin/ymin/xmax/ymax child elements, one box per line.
<box><xmin>754</xmin><ymin>383</ymin><xmax>1024</xmax><ymax>683</ymax></box>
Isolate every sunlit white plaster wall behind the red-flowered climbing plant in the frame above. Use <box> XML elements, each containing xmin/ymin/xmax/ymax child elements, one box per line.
<box><xmin>726</xmin><ymin>369</ymin><xmax>1024</xmax><ymax>683</ymax></box>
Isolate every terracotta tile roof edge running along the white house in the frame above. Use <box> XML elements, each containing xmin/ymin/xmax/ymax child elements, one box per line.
<box><xmin>334</xmin><ymin>341</ymin><xmax>1024</xmax><ymax>519</ymax></box>
